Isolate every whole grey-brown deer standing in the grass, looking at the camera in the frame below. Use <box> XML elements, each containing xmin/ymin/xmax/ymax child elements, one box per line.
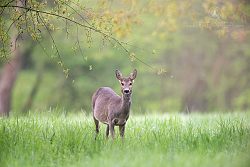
<box><xmin>92</xmin><ymin>69</ymin><xmax>137</xmax><ymax>140</ymax></box>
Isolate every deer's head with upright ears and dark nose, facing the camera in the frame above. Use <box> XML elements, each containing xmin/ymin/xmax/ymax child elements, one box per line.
<box><xmin>115</xmin><ymin>69</ymin><xmax>137</xmax><ymax>97</ymax></box>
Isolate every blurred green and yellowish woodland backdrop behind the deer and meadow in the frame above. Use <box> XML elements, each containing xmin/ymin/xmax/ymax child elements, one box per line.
<box><xmin>0</xmin><ymin>0</ymin><xmax>250</xmax><ymax>114</ymax></box>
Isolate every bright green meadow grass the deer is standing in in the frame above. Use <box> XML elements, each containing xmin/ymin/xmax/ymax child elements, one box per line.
<box><xmin>0</xmin><ymin>113</ymin><xmax>250</xmax><ymax>167</ymax></box>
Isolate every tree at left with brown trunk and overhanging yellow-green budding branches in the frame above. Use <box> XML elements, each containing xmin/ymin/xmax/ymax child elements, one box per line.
<box><xmin>0</xmin><ymin>0</ymin><xmax>144</xmax><ymax>115</ymax></box>
